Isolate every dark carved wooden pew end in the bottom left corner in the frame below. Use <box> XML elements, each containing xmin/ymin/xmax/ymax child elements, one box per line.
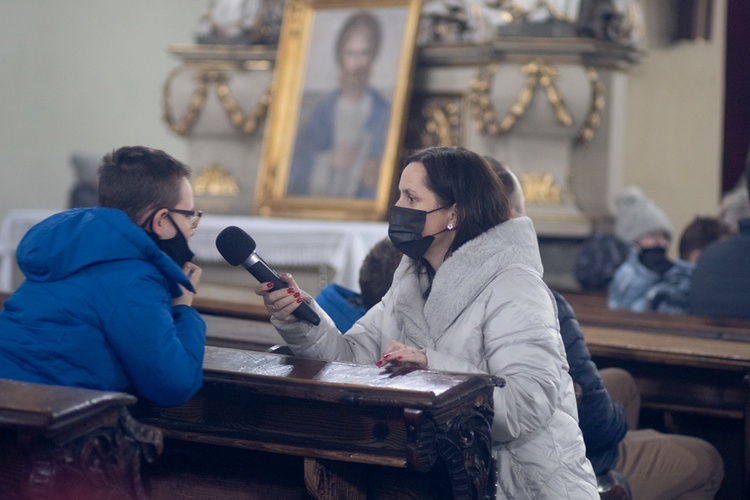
<box><xmin>0</xmin><ymin>379</ymin><xmax>162</xmax><ymax>500</ymax></box>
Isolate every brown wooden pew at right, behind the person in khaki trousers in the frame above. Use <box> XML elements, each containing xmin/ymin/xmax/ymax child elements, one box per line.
<box><xmin>563</xmin><ymin>293</ymin><xmax>750</xmax><ymax>498</ymax></box>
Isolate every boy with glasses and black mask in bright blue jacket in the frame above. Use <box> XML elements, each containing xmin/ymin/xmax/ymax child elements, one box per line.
<box><xmin>0</xmin><ymin>146</ymin><xmax>206</xmax><ymax>406</ymax></box>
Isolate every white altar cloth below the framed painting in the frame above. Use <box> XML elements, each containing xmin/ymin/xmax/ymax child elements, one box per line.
<box><xmin>0</xmin><ymin>210</ymin><xmax>388</xmax><ymax>293</ymax></box>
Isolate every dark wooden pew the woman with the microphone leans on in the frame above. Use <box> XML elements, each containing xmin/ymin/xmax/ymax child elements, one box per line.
<box><xmin>137</xmin><ymin>346</ymin><xmax>501</xmax><ymax>499</ymax></box>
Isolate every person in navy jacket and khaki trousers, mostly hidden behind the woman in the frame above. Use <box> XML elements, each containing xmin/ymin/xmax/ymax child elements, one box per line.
<box><xmin>485</xmin><ymin>157</ymin><xmax>724</xmax><ymax>500</ymax></box>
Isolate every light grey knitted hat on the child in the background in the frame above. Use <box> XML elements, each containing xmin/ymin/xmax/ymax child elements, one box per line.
<box><xmin>615</xmin><ymin>186</ymin><xmax>672</xmax><ymax>243</ymax></box>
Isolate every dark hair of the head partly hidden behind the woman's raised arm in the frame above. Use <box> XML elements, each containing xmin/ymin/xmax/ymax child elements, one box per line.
<box><xmin>359</xmin><ymin>238</ymin><xmax>403</xmax><ymax>309</ymax></box>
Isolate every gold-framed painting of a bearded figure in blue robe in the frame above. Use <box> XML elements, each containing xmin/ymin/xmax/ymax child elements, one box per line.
<box><xmin>254</xmin><ymin>0</ymin><xmax>420</xmax><ymax>220</ymax></box>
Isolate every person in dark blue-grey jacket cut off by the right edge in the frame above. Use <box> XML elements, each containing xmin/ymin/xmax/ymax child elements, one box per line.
<box><xmin>690</xmin><ymin>167</ymin><xmax>750</xmax><ymax>318</ymax></box>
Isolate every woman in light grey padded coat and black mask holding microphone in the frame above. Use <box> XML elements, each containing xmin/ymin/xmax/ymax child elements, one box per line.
<box><xmin>256</xmin><ymin>147</ymin><xmax>599</xmax><ymax>500</ymax></box>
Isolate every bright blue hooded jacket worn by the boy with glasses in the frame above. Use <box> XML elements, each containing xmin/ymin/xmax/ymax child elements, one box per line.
<box><xmin>0</xmin><ymin>207</ymin><xmax>206</xmax><ymax>406</ymax></box>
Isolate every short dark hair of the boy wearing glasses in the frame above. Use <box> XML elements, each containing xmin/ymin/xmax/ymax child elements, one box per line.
<box><xmin>98</xmin><ymin>146</ymin><xmax>190</xmax><ymax>224</ymax></box>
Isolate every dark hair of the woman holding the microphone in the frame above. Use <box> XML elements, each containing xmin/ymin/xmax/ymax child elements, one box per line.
<box><xmin>404</xmin><ymin>146</ymin><xmax>511</xmax><ymax>274</ymax></box>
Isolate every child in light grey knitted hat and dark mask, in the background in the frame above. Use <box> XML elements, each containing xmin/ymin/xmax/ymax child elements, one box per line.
<box><xmin>607</xmin><ymin>186</ymin><xmax>693</xmax><ymax>314</ymax></box>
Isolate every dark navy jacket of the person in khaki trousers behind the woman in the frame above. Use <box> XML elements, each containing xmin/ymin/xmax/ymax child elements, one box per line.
<box><xmin>553</xmin><ymin>291</ymin><xmax>628</xmax><ymax>475</ymax></box>
